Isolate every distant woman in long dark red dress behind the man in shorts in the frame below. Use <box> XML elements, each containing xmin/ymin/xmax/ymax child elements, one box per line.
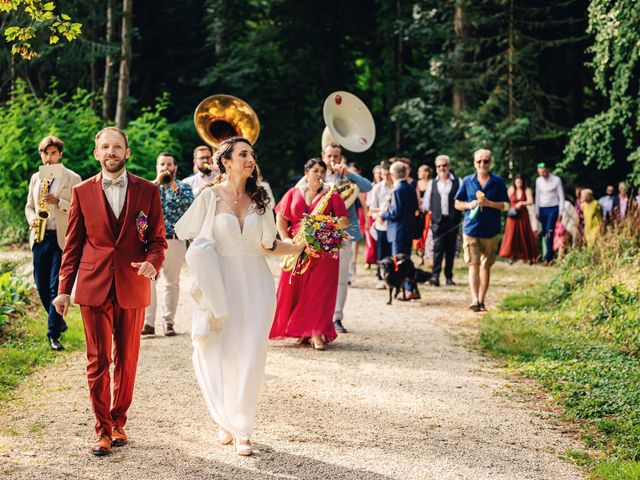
<box><xmin>498</xmin><ymin>175</ymin><xmax>539</xmax><ymax>263</ymax></box>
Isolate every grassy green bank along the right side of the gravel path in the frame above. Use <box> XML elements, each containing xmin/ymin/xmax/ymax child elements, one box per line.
<box><xmin>480</xmin><ymin>230</ymin><xmax>640</xmax><ymax>480</ymax></box>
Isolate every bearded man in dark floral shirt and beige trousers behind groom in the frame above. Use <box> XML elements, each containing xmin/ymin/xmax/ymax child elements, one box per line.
<box><xmin>142</xmin><ymin>152</ymin><xmax>193</xmax><ymax>337</ymax></box>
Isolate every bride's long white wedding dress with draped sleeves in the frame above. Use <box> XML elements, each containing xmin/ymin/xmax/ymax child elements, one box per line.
<box><xmin>175</xmin><ymin>188</ymin><xmax>276</xmax><ymax>437</ymax></box>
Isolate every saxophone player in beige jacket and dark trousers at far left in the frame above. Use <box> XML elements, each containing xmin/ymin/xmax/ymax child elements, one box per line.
<box><xmin>24</xmin><ymin>135</ymin><xmax>82</xmax><ymax>351</ymax></box>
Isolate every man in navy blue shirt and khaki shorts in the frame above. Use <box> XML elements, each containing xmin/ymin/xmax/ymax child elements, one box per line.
<box><xmin>455</xmin><ymin>148</ymin><xmax>509</xmax><ymax>312</ymax></box>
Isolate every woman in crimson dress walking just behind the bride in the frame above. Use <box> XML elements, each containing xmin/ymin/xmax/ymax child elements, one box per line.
<box><xmin>269</xmin><ymin>158</ymin><xmax>349</xmax><ymax>350</ymax></box>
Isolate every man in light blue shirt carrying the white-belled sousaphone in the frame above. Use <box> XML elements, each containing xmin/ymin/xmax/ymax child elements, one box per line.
<box><xmin>322</xmin><ymin>143</ymin><xmax>373</xmax><ymax>333</ymax></box>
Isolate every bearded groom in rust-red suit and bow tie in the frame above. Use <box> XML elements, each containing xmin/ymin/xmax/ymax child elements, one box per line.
<box><xmin>53</xmin><ymin>127</ymin><xmax>167</xmax><ymax>455</ymax></box>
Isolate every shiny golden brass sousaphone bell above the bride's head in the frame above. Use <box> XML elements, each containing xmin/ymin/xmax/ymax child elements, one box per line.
<box><xmin>193</xmin><ymin>95</ymin><xmax>260</xmax><ymax>149</ymax></box>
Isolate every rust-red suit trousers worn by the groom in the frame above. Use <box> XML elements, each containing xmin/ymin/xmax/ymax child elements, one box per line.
<box><xmin>80</xmin><ymin>294</ymin><xmax>145</xmax><ymax>436</ymax></box>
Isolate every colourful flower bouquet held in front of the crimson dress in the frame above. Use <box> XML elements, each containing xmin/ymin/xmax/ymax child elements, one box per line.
<box><xmin>292</xmin><ymin>213</ymin><xmax>350</xmax><ymax>275</ymax></box>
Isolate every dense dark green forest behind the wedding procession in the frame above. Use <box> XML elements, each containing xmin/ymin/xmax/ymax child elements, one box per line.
<box><xmin>0</xmin><ymin>0</ymin><xmax>640</xmax><ymax>242</ymax></box>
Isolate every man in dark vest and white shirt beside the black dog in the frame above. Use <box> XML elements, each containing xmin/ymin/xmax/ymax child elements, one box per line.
<box><xmin>422</xmin><ymin>155</ymin><xmax>462</xmax><ymax>287</ymax></box>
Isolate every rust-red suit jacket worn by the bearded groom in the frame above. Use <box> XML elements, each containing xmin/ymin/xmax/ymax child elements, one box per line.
<box><xmin>58</xmin><ymin>172</ymin><xmax>167</xmax><ymax>308</ymax></box>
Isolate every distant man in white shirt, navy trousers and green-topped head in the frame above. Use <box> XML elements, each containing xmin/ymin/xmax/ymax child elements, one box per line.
<box><xmin>535</xmin><ymin>162</ymin><xmax>564</xmax><ymax>265</ymax></box>
